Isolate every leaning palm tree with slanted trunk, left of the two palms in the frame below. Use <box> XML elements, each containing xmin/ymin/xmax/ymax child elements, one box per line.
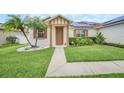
<box><xmin>3</xmin><ymin>15</ymin><xmax>33</xmax><ymax>47</ymax></box>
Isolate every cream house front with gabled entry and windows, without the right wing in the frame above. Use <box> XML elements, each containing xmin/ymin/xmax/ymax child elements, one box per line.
<box><xmin>29</xmin><ymin>15</ymin><xmax>100</xmax><ymax>47</ymax></box>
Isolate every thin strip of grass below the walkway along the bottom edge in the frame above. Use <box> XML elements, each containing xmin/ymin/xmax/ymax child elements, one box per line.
<box><xmin>48</xmin><ymin>73</ymin><xmax>124</xmax><ymax>78</ymax></box>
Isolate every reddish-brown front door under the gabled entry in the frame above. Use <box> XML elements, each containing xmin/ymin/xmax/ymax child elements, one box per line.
<box><xmin>56</xmin><ymin>27</ymin><xmax>63</xmax><ymax>45</ymax></box>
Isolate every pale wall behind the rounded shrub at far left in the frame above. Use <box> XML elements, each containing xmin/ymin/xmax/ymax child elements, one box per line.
<box><xmin>0</xmin><ymin>31</ymin><xmax>29</xmax><ymax>44</ymax></box>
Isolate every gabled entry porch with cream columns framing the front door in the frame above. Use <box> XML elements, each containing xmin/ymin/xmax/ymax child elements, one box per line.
<box><xmin>46</xmin><ymin>15</ymin><xmax>71</xmax><ymax>47</ymax></box>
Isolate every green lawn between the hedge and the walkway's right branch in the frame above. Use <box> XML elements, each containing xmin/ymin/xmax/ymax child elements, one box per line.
<box><xmin>65</xmin><ymin>45</ymin><xmax>124</xmax><ymax>62</ymax></box>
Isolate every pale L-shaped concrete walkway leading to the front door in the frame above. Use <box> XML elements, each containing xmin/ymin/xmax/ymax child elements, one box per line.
<box><xmin>46</xmin><ymin>47</ymin><xmax>124</xmax><ymax>76</ymax></box>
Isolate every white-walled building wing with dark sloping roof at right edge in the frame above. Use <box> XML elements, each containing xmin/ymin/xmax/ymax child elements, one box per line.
<box><xmin>99</xmin><ymin>16</ymin><xmax>124</xmax><ymax>44</ymax></box>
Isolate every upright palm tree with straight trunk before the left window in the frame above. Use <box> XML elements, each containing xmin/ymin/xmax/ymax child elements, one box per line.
<box><xmin>25</xmin><ymin>17</ymin><xmax>47</xmax><ymax>47</ymax></box>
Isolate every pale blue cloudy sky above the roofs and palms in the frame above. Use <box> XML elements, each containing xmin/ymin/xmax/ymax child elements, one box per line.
<box><xmin>0</xmin><ymin>14</ymin><xmax>123</xmax><ymax>23</ymax></box>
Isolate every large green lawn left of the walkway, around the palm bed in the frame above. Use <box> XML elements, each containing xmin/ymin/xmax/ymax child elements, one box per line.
<box><xmin>0</xmin><ymin>45</ymin><xmax>54</xmax><ymax>78</ymax></box>
